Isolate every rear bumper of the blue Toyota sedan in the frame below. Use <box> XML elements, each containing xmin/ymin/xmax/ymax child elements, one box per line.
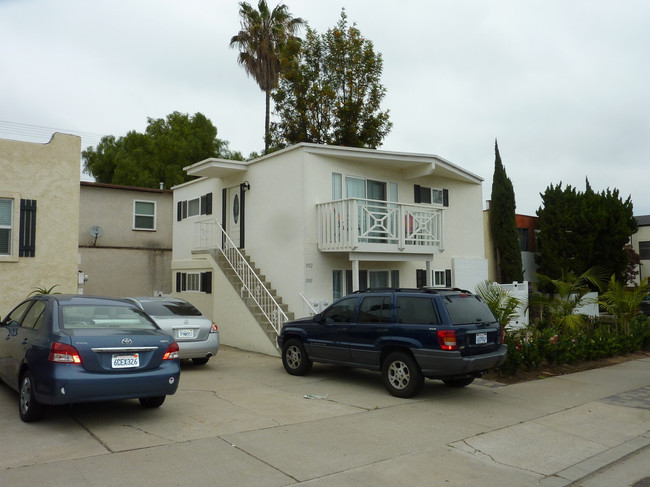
<box><xmin>34</xmin><ymin>360</ymin><xmax>181</xmax><ymax>405</ymax></box>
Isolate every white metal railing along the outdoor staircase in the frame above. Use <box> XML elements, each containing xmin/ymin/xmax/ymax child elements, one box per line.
<box><xmin>195</xmin><ymin>220</ymin><xmax>289</xmax><ymax>334</ymax></box>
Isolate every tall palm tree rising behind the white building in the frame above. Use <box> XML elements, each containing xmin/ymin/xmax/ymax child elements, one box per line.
<box><xmin>230</xmin><ymin>0</ymin><xmax>304</xmax><ymax>154</ymax></box>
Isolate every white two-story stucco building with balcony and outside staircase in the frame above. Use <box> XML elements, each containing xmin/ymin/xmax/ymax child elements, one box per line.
<box><xmin>172</xmin><ymin>144</ymin><xmax>488</xmax><ymax>353</ymax></box>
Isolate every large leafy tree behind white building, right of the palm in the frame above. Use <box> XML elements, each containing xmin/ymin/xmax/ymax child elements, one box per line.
<box><xmin>273</xmin><ymin>10</ymin><xmax>392</xmax><ymax>148</ymax></box>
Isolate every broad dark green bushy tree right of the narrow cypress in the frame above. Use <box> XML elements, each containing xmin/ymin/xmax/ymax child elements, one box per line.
<box><xmin>536</xmin><ymin>181</ymin><xmax>637</xmax><ymax>280</ymax></box>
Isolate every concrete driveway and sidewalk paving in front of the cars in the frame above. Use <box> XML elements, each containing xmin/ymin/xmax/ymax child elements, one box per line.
<box><xmin>0</xmin><ymin>347</ymin><xmax>650</xmax><ymax>487</ymax></box>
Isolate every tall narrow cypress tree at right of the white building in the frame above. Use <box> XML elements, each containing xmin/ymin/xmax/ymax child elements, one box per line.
<box><xmin>489</xmin><ymin>141</ymin><xmax>524</xmax><ymax>283</ymax></box>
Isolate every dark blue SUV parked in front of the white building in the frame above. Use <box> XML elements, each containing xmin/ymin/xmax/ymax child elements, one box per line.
<box><xmin>278</xmin><ymin>288</ymin><xmax>507</xmax><ymax>397</ymax></box>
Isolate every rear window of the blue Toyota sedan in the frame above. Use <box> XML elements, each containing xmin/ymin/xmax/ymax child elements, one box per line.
<box><xmin>61</xmin><ymin>305</ymin><xmax>156</xmax><ymax>330</ymax></box>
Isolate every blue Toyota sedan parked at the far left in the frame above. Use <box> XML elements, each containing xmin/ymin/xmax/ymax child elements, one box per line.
<box><xmin>0</xmin><ymin>294</ymin><xmax>180</xmax><ymax>422</ymax></box>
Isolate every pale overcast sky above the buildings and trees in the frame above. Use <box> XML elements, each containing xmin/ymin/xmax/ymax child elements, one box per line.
<box><xmin>0</xmin><ymin>0</ymin><xmax>650</xmax><ymax>215</ymax></box>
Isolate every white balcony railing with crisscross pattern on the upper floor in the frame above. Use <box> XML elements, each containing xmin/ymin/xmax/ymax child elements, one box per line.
<box><xmin>316</xmin><ymin>198</ymin><xmax>444</xmax><ymax>254</ymax></box>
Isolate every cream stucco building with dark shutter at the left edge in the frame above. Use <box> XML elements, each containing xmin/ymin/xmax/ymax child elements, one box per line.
<box><xmin>0</xmin><ymin>133</ymin><xmax>81</xmax><ymax>316</ymax></box>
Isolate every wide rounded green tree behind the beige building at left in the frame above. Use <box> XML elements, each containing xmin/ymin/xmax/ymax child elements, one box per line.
<box><xmin>82</xmin><ymin>112</ymin><xmax>243</xmax><ymax>188</ymax></box>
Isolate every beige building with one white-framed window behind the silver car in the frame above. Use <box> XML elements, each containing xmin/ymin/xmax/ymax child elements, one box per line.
<box><xmin>76</xmin><ymin>182</ymin><xmax>174</xmax><ymax>297</ymax></box>
